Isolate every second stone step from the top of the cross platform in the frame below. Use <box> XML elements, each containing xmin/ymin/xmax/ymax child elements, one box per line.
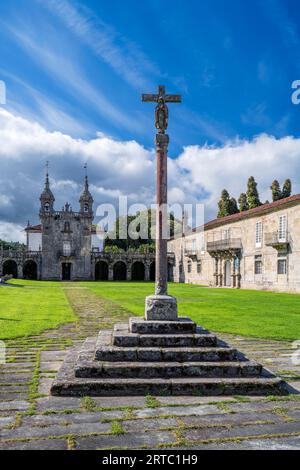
<box><xmin>113</xmin><ymin>325</ymin><xmax>217</xmax><ymax>348</ymax></box>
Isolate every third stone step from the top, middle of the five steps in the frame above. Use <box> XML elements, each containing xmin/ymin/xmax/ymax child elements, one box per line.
<box><xmin>95</xmin><ymin>343</ymin><xmax>237</xmax><ymax>362</ymax></box>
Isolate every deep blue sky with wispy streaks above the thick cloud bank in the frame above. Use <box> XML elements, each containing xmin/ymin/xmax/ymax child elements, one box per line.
<box><xmin>0</xmin><ymin>0</ymin><xmax>300</xmax><ymax>154</ymax></box>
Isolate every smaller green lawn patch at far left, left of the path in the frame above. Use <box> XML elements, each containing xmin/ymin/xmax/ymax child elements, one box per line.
<box><xmin>0</xmin><ymin>280</ymin><xmax>76</xmax><ymax>339</ymax></box>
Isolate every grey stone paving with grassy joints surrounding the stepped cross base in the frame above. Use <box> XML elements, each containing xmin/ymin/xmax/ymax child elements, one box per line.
<box><xmin>0</xmin><ymin>285</ymin><xmax>300</xmax><ymax>450</ymax></box>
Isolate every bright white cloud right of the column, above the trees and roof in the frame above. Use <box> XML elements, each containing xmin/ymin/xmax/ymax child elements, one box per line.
<box><xmin>176</xmin><ymin>134</ymin><xmax>300</xmax><ymax>218</ymax></box>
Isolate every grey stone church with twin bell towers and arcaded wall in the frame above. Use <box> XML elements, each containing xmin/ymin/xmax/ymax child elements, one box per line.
<box><xmin>0</xmin><ymin>173</ymin><xmax>174</xmax><ymax>281</ymax></box>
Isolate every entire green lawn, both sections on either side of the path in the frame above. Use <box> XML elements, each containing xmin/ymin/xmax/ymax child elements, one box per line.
<box><xmin>0</xmin><ymin>280</ymin><xmax>300</xmax><ymax>340</ymax></box>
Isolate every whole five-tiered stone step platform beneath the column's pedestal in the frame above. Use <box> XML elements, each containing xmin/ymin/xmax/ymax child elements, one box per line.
<box><xmin>51</xmin><ymin>317</ymin><xmax>287</xmax><ymax>397</ymax></box>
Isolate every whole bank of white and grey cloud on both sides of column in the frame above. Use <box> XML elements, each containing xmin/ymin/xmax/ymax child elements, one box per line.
<box><xmin>0</xmin><ymin>109</ymin><xmax>300</xmax><ymax>239</ymax></box>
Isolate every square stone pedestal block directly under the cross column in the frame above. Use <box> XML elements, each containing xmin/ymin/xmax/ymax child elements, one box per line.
<box><xmin>145</xmin><ymin>295</ymin><xmax>178</xmax><ymax>321</ymax></box>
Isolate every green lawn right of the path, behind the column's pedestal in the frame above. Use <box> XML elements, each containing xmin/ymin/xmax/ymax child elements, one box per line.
<box><xmin>81</xmin><ymin>282</ymin><xmax>300</xmax><ymax>340</ymax></box>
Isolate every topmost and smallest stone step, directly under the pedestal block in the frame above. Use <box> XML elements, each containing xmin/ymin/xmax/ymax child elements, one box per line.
<box><xmin>129</xmin><ymin>317</ymin><xmax>197</xmax><ymax>335</ymax></box>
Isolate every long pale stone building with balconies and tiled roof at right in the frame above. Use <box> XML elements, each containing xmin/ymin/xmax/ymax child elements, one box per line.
<box><xmin>168</xmin><ymin>194</ymin><xmax>300</xmax><ymax>292</ymax></box>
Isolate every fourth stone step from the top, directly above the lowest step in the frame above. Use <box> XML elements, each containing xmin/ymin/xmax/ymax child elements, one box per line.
<box><xmin>75</xmin><ymin>361</ymin><xmax>262</xmax><ymax>379</ymax></box>
